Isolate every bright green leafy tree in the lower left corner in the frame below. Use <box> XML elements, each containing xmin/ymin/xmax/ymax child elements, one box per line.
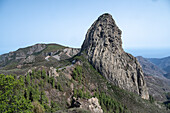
<box><xmin>0</xmin><ymin>74</ymin><xmax>33</xmax><ymax>113</ymax></box>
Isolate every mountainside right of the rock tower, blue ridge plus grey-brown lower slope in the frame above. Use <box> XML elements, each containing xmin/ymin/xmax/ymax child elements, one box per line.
<box><xmin>136</xmin><ymin>56</ymin><xmax>170</xmax><ymax>102</ymax></box>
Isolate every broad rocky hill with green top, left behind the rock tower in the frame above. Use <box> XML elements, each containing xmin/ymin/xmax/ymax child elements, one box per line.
<box><xmin>0</xmin><ymin>44</ymin><xmax>79</xmax><ymax>70</ymax></box>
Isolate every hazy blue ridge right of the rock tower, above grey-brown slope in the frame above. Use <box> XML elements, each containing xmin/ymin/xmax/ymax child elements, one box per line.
<box><xmin>136</xmin><ymin>56</ymin><xmax>166</xmax><ymax>77</ymax></box>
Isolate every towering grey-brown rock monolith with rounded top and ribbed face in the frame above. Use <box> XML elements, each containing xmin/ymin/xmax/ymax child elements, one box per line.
<box><xmin>81</xmin><ymin>14</ymin><xmax>149</xmax><ymax>99</ymax></box>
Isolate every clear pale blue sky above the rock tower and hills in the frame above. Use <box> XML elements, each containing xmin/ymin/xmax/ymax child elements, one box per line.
<box><xmin>0</xmin><ymin>0</ymin><xmax>170</xmax><ymax>58</ymax></box>
